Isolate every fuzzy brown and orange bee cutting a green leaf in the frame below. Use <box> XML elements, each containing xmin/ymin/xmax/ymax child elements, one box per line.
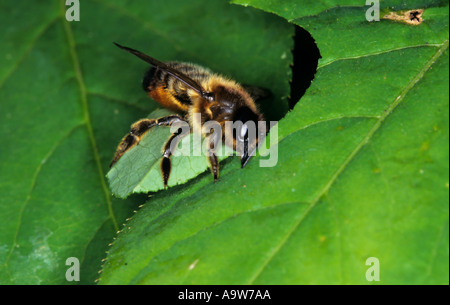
<box><xmin>110</xmin><ymin>43</ymin><xmax>270</xmax><ymax>188</ymax></box>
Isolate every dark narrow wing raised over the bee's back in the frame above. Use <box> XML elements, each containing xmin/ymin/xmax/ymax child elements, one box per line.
<box><xmin>114</xmin><ymin>42</ymin><xmax>210</xmax><ymax>99</ymax></box>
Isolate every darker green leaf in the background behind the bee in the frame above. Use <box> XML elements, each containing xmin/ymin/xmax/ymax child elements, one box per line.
<box><xmin>0</xmin><ymin>0</ymin><xmax>293</xmax><ymax>284</ymax></box>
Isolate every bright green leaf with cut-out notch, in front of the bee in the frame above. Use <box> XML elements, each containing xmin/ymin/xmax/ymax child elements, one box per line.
<box><xmin>100</xmin><ymin>0</ymin><xmax>449</xmax><ymax>284</ymax></box>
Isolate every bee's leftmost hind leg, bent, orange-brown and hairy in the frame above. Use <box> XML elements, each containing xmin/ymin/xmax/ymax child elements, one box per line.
<box><xmin>109</xmin><ymin>115</ymin><xmax>187</xmax><ymax>167</ymax></box>
